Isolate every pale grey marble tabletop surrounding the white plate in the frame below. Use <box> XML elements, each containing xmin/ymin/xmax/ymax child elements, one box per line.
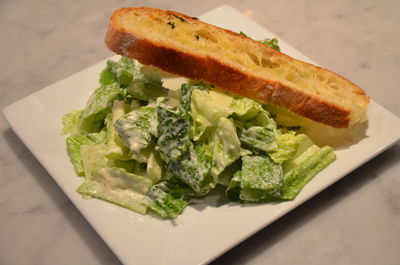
<box><xmin>0</xmin><ymin>0</ymin><xmax>400</xmax><ymax>265</ymax></box>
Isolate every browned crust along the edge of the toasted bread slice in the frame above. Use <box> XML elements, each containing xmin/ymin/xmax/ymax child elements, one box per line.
<box><xmin>105</xmin><ymin>8</ymin><xmax>369</xmax><ymax>128</ymax></box>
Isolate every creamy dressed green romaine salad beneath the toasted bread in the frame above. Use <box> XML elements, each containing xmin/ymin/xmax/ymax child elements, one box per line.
<box><xmin>63</xmin><ymin>40</ymin><xmax>336</xmax><ymax>218</ymax></box>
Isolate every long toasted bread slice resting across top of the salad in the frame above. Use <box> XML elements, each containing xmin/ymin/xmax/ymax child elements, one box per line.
<box><xmin>105</xmin><ymin>7</ymin><xmax>369</xmax><ymax>128</ymax></box>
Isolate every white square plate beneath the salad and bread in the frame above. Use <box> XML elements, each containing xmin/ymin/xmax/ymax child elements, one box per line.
<box><xmin>4</xmin><ymin>6</ymin><xmax>400</xmax><ymax>265</ymax></box>
